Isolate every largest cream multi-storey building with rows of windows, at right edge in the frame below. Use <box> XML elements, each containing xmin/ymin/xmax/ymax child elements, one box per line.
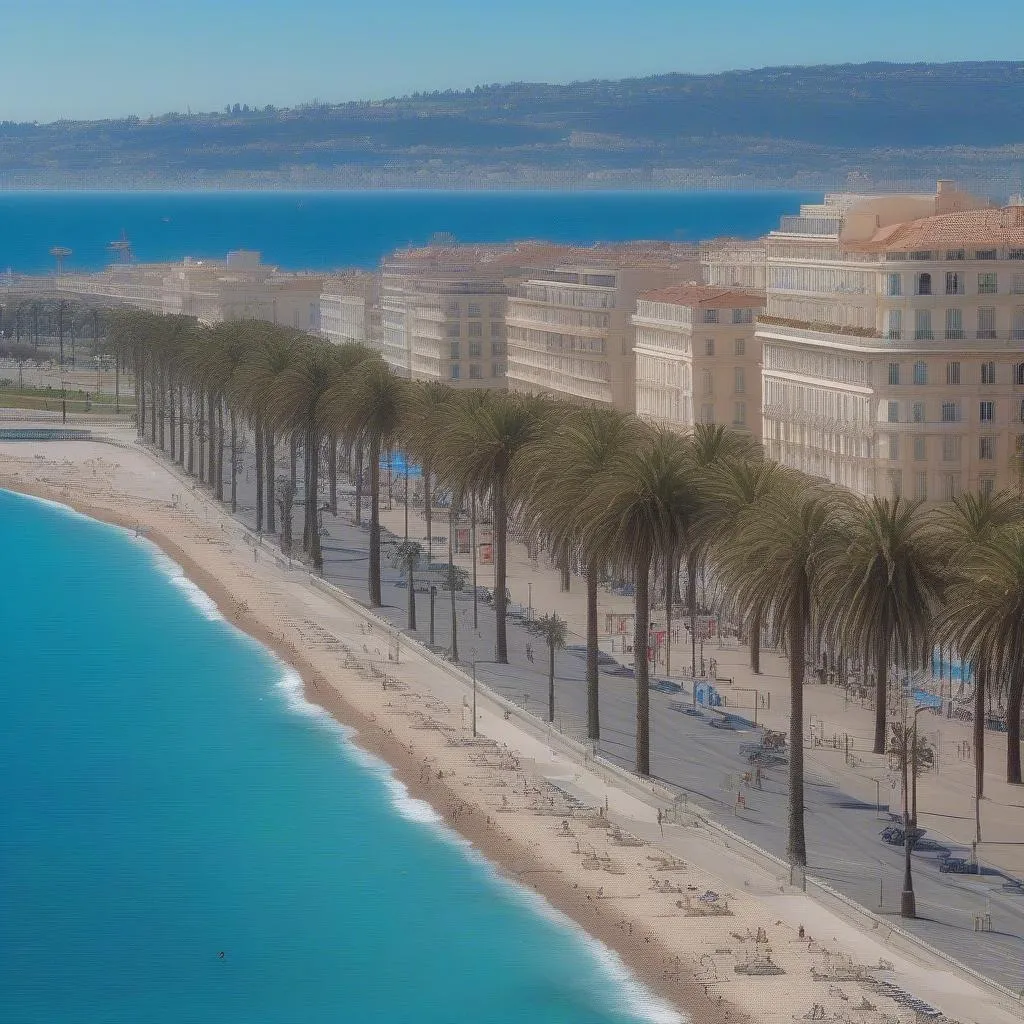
<box><xmin>757</xmin><ymin>181</ymin><xmax>1024</xmax><ymax>501</ymax></box>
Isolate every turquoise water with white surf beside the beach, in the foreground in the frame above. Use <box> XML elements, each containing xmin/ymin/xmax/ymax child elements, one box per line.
<box><xmin>0</xmin><ymin>492</ymin><xmax>677</xmax><ymax>1024</ymax></box>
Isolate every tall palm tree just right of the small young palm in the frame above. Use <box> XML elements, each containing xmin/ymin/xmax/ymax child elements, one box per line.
<box><xmin>522</xmin><ymin>408</ymin><xmax>640</xmax><ymax>739</ymax></box>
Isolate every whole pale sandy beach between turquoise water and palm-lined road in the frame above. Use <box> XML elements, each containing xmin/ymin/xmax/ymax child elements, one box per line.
<box><xmin>0</xmin><ymin>432</ymin><xmax>1020</xmax><ymax>1024</ymax></box>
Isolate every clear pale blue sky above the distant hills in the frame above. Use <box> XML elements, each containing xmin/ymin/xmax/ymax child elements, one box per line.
<box><xmin>8</xmin><ymin>0</ymin><xmax>1024</xmax><ymax>121</ymax></box>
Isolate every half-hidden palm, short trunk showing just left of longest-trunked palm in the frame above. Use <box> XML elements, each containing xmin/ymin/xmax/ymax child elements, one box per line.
<box><xmin>707</xmin><ymin>459</ymin><xmax>795</xmax><ymax>675</ymax></box>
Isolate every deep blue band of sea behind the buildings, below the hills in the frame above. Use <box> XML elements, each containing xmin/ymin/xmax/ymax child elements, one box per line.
<box><xmin>0</xmin><ymin>190</ymin><xmax>821</xmax><ymax>273</ymax></box>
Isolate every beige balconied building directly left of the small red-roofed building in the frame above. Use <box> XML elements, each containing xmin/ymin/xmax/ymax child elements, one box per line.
<box><xmin>507</xmin><ymin>243</ymin><xmax>699</xmax><ymax>412</ymax></box>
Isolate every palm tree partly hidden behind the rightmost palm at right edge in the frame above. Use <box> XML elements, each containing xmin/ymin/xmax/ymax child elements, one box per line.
<box><xmin>936</xmin><ymin>490</ymin><xmax>1024</xmax><ymax>831</ymax></box>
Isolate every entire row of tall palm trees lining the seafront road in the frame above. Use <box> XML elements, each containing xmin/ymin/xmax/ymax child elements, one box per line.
<box><xmin>109</xmin><ymin>311</ymin><xmax>1024</xmax><ymax>864</ymax></box>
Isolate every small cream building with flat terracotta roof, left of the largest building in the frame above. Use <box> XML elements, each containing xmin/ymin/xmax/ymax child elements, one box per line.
<box><xmin>633</xmin><ymin>284</ymin><xmax>765</xmax><ymax>439</ymax></box>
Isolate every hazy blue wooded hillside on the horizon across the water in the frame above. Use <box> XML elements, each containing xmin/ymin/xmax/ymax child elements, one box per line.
<box><xmin>6</xmin><ymin>61</ymin><xmax>1024</xmax><ymax>190</ymax></box>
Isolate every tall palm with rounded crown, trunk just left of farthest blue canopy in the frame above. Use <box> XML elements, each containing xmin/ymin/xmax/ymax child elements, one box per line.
<box><xmin>321</xmin><ymin>358</ymin><xmax>409</xmax><ymax>608</ymax></box>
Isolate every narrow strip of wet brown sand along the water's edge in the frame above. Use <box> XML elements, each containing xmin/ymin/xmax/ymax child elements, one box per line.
<box><xmin>0</xmin><ymin>479</ymin><xmax>737</xmax><ymax>1024</ymax></box>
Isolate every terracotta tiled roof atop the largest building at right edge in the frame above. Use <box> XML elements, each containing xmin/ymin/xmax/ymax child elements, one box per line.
<box><xmin>843</xmin><ymin>206</ymin><xmax>1024</xmax><ymax>252</ymax></box>
